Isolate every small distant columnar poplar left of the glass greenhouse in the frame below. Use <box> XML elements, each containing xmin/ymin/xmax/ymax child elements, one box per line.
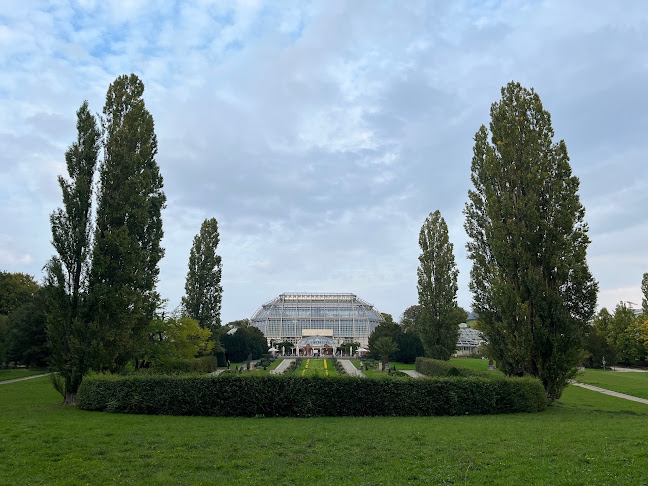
<box><xmin>182</xmin><ymin>218</ymin><xmax>223</xmax><ymax>330</ymax></box>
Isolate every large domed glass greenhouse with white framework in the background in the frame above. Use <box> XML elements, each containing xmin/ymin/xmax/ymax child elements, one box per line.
<box><xmin>251</xmin><ymin>293</ymin><xmax>384</xmax><ymax>354</ymax></box>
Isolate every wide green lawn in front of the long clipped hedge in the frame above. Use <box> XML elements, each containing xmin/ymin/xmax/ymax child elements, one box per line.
<box><xmin>0</xmin><ymin>377</ymin><xmax>648</xmax><ymax>485</ymax></box>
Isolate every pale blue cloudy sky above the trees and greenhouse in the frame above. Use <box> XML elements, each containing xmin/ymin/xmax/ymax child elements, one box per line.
<box><xmin>0</xmin><ymin>0</ymin><xmax>648</xmax><ymax>322</ymax></box>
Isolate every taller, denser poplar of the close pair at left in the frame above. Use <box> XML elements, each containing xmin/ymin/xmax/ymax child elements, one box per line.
<box><xmin>90</xmin><ymin>74</ymin><xmax>166</xmax><ymax>369</ymax></box>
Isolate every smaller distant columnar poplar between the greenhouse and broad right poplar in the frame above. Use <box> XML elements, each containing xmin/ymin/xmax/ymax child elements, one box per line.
<box><xmin>416</xmin><ymin>210</ymin><xmax>459</xmax><ymax>360</ymax></box>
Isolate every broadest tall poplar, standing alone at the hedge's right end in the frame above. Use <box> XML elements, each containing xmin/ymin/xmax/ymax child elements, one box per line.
<box><xmin>464</xmin><ymin>82</ymin><xmax>598</xmax><ymax>400</ymax></box>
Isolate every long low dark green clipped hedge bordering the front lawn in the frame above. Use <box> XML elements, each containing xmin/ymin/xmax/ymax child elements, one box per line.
<box><xmin>77</xmin><ymin>375</ymin><xmax>546</xmax><ymax>417</ymax></box>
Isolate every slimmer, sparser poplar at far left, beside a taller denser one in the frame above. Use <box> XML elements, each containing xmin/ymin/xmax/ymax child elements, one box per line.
<box><xmin>46</xmin><ymin>102</ymin><xmax>100</xmax><ymax>404</ymax></box>
